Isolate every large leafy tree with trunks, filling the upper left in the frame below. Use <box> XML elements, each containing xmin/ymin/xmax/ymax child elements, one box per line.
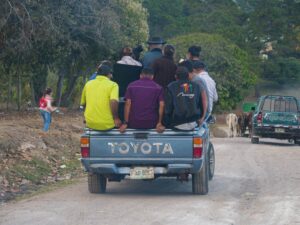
<box><xmin>0</xmin><ymin>0</ymin><xmax>148</xmax><ymax>109</ymax></box>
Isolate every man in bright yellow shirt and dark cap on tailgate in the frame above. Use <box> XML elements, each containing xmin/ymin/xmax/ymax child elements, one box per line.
<box><xmin>80</xmin><ymin>65</ymin><xmax>121</xmax><ymax>130</ymax></box>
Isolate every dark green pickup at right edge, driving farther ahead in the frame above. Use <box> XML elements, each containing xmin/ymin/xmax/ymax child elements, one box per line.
<box><xmin>251</xmin><ymin>95</ymin><xmax>300</xmax><ymax>144</ymax></box>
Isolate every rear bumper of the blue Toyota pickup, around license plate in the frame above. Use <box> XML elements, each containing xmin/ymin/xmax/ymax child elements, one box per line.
<box><xmin>81</xmin><ymin>158</ymin><xmax>202</xmax><ymax>175</ymax></box>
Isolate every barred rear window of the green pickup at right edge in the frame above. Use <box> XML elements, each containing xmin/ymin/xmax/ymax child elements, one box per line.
<box><xmin>262</xmin><ymin>97</ymin><xmax>298</xmax><ymax>113</ymax></box>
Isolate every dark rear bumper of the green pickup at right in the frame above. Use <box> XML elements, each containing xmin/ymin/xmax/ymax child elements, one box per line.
<box><xmin>254</xmin><ymin>126</ymin><xmax>300</xmax><ymax>139</ymax></box>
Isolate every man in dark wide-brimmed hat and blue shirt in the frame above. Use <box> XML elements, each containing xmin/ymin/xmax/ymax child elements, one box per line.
<box><xmin>141</xmin><ymin>37</ymin><xmax>166</xmax><ymax>67</ymax></box>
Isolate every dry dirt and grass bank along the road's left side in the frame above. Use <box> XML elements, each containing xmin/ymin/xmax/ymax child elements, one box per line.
<box><xmin>0</xmin><ymin>111</ymin><xmax>83</xmax><ymax>202</ymax></box>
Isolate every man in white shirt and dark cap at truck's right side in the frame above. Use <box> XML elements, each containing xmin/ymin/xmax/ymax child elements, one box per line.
<box><xmin>193</xmin><ymin>60</ymin><xmax>218</xmax><ymax>114</ymax></box>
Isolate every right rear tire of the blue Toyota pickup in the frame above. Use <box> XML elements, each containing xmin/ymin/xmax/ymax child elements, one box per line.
<box><xmin>192</xmin><ymin>157</ymin><xmax>208</xmax><ymax>195</ymax></box>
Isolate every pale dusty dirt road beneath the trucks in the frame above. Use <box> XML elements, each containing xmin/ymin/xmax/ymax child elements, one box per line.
<box><xmin>0</xmin><ymin>138</ymin><xmax>300</xmax><ymax>225</ymax></box>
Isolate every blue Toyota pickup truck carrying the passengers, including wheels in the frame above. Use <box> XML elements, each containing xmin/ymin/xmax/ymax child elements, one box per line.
<box><xmin>81</xmin><ymin>125</ymin><xmax>215</xmax><ymax>195</ymax></box>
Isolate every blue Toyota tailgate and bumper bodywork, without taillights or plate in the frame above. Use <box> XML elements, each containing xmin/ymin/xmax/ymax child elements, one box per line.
<box><xmin>82</xmin><ymin>128</ymin><xmax>207</xmax><ymax>174</ymax></box>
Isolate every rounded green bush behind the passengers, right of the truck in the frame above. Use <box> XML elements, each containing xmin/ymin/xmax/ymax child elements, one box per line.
<box><xmin>170</xmin><ymin>33</ymin><xmax>257</xmax><ymax>110</ymax></box>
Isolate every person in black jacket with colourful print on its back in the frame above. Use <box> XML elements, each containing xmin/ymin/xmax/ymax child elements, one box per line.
<box><xmin>164</xmin><ymin>66</ymin><xmax>203</xmax><ymax>130</ymax></box>
